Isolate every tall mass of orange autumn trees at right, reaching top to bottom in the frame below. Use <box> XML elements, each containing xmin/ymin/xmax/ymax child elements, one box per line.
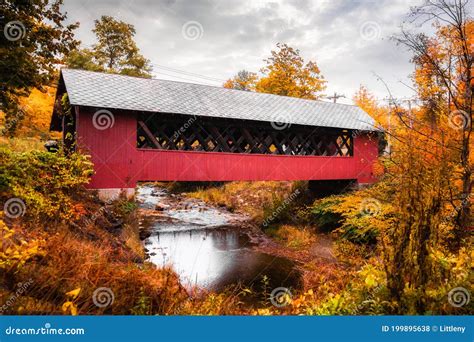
<box><xmin>381</xmin><ymin>0</ymin><xmax>474</xmax><ymax>313</ymax></box>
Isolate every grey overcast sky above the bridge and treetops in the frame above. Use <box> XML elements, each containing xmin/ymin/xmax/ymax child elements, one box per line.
<box><xmin>64</xmin><ymin>0</ymin><xmax>419</xmax><ymax>103</ymax></box>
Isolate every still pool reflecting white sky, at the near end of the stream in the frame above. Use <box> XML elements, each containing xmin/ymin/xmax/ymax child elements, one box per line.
<box><xmin>147</xmin><ymin>227</ymin><xmax>296</xmax><ymax>291</ymax></box>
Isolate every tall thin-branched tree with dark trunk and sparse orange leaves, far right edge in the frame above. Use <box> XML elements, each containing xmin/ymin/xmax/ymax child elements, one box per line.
<box><xmin>398</xmin><ymin>0</ymin><xmax>474</xmax><ymax>244</ymax></box>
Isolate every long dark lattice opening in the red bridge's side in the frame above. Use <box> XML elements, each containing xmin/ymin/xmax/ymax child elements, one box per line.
<box><xmin>137</xmin><ymin>118</ymin><xmax>353</xmax><ymax>156</ymax></box>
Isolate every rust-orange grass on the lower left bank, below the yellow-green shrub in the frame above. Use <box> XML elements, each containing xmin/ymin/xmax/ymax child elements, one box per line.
<box><xmin>1</xmin><ymin>194</ymin><xmax>191</xmax><ymax>314</ymax></box>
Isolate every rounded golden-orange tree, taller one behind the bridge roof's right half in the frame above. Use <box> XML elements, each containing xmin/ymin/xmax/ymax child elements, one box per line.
<box><xmin>255</xmin><ymin>43</ymin><xmax>326</xmax><ymax>100</ymax></box>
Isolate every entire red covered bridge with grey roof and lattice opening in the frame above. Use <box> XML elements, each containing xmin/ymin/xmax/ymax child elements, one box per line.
<box><xmin>51</xmin><ymin>69</ymin><xmax>378</xmax><ymax>198</ymax></box>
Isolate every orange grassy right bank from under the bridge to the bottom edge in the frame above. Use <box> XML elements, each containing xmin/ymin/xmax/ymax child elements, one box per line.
<box><xmin>183</xmin><ymin>182</ymin><xmax>384</xmax><ymax>315</ymax></box>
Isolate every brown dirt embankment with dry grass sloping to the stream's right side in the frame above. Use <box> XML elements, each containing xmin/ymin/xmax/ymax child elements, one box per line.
<box><xmin>167</xmin><ymin>182</ymin><xmax>355</xmax><ymax>289</ymax></box>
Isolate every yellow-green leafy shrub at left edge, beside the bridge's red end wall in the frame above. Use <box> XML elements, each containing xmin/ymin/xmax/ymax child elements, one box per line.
<box><xmin>0</xmin><ymin>148</ymin><xmax>93</xmax><ymax>221</ymax></box>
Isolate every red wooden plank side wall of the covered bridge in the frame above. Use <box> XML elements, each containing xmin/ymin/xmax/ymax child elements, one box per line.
<box><xmin>76</xmin><ymin>108</ymin><xmax>377</xmax><ymax>192</ymax></box>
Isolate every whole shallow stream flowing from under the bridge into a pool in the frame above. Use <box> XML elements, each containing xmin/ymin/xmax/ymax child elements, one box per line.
<box><xmin>137</xmin><ymin>185</ymin><xmax>300</xmax><ymax>292</ymax></box>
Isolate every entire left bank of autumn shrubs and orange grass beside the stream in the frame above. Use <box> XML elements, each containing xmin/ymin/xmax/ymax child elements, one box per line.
<box><xmin>0</xmin><ymin>148</ymin><xmax>193</xmax><ymax>314</ymax></box>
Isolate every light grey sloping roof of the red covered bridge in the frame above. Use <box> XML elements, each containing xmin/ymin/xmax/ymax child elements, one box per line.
<box><xmin>61</xmin><ymin>69</ymin><xmax>376</xmax><ymax>131</ymax></box>
